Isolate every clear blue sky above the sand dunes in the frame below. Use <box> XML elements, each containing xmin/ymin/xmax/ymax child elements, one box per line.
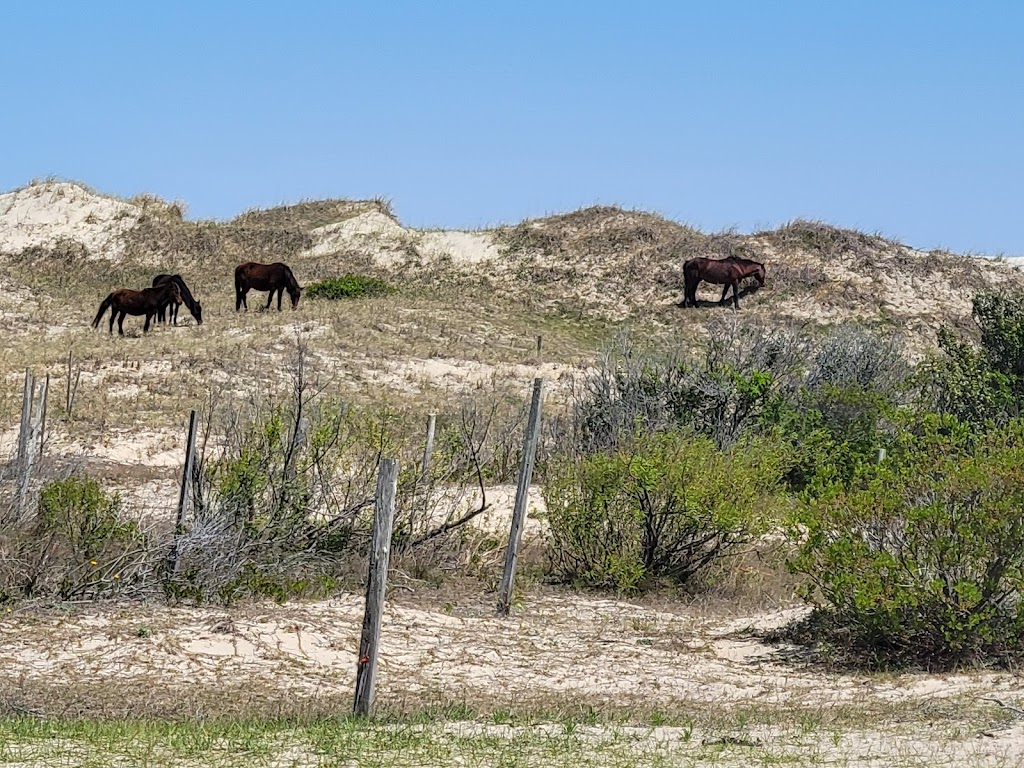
<box><xmin>0</xmin><ymin>0</ymin><xmax>1024</xmax><ymax>255</ymax></box>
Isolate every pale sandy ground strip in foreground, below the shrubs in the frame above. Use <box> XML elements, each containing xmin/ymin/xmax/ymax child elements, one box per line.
<box><xmin>0</xmin><ymin>589</ymin><xmax>1024</xmax><ymax>765</ymax></box>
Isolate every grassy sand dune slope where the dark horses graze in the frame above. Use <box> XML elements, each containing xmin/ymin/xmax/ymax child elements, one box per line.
<box><xmin>0</xmin><ymin>181</ymin><xmax>1024</xmax><ymax>512</ymax></box>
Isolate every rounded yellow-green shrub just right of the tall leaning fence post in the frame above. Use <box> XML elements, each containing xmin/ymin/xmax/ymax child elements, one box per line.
<box><xmin>544</xmin><ymin>432</ymin><xmax>784</xmax><ymax>593</ymax></box>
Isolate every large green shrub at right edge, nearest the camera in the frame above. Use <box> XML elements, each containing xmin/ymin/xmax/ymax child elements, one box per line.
<box><xmin>791</xmin><ymin>417</ymin><xmax>1024</xmax><ymax>669</ymax></box>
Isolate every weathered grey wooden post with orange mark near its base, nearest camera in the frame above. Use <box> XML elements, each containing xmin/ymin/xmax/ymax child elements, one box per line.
<box><xmin>352</xmin><ymin>459</ymin><xmax>398</xmax><ymax>717</ymax></box>
